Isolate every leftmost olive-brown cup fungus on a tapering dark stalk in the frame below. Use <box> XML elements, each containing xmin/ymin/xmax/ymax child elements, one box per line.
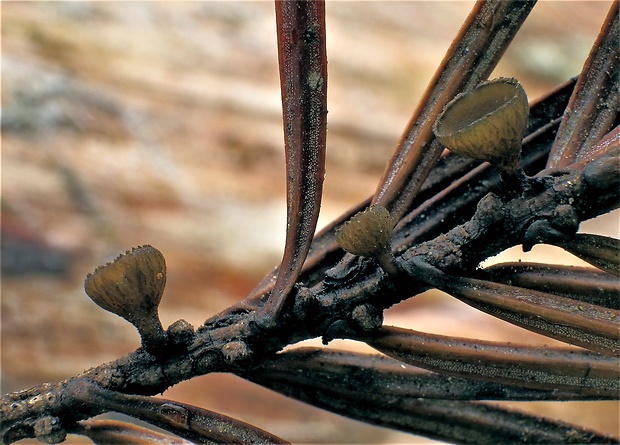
<box><xmin>84</xmin><ymin>245</ymin><xmax>167</xmax><ymax>353</ymax></box>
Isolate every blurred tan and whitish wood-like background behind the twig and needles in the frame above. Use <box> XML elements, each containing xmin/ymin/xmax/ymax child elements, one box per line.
<box><xmin>1</xmin><ymin>1</ymin><xmax>619</xmax><ymax>443</ymax></box>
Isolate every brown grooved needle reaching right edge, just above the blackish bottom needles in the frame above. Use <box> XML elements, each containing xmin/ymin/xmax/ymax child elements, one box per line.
<box><xmin>360</xmin><ymin>326</ymin><xmax>620</xmax><ymax>398</ymax></box>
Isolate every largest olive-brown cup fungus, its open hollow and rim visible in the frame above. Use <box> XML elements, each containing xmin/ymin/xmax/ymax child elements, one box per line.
<box><xmin>433</xmin><ymin>78</ymin><xmax>529</xmax><ymax>174</ymax></box>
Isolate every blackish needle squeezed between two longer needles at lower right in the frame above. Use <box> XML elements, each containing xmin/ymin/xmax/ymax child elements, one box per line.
<box><xmin>239</xmin><ymin>348</ymin><xmax>607</xmax><ymax>401</ymax></box>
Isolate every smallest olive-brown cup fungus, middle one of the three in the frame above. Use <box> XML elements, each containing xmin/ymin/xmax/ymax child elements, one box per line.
<box><xmin>336</xmin><ymin>205</ymin><xmax>400</xmax><ymax>275</ymax></box>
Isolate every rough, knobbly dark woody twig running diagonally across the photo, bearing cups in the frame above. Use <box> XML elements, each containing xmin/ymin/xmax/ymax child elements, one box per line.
<box><xmin>0</xmin><ymin>150</ymin><xmax>620</xmax><ymax>442</ymax></box>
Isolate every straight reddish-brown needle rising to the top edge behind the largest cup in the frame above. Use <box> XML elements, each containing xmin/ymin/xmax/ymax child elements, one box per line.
<box><xmin>372</xmin><ymin>1</ymin><xmax>536</xmax><ymax>223</ymax></box>
